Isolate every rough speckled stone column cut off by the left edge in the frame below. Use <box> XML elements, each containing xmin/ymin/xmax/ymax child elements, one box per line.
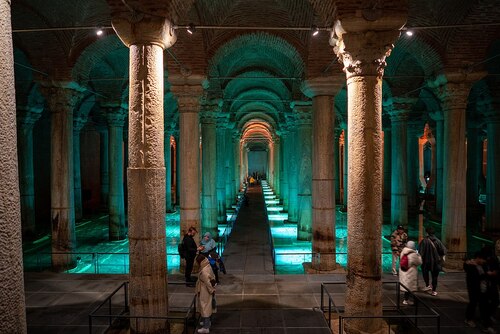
<box><xmin>0</xmin><ymin>0</ymin><xmax>27</xmax><ymax>326</ymax></box>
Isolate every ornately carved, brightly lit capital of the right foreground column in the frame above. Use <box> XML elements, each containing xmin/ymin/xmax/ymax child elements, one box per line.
<box><xmin>334</xmin><ymin>30</ymin><xmax>400</xmax><ymax>79</ymax></box>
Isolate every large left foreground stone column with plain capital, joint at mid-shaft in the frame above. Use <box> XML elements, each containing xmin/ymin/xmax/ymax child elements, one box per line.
<box><xmin>112</xmin><ymin>14</ymin><xmax>176</xmax><ymax>333</ymax></box>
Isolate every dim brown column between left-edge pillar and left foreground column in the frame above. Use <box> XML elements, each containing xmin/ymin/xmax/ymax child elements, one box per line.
<box><xmin>42</xmin><ymin>84</ymin><xmax>81</xmax><ymax>271</ymax></box>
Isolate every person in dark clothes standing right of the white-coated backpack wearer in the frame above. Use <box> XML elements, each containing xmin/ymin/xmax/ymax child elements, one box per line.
<box><xmin>418</xmin><ymin>227</ymin><xmax>446</xmax><ymax>296</ymax></box>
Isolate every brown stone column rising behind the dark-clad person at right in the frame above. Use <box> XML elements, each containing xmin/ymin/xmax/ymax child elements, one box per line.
<box><xmin>429</xmin><ymin>72</ymin><xmax>483</xmax><ymax>269</ymax></box>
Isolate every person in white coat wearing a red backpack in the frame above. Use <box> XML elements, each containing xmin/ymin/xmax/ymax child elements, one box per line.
<box><xmin>399</xmin><ymin>240</ymin><xmax>422</xmax><ymax>305</ymax></box>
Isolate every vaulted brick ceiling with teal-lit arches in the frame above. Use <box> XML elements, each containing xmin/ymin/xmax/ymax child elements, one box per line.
<box><xmin>12</xmin><ymin>0</ymin><xmax>500</xmax><ymax>144</ymax></box>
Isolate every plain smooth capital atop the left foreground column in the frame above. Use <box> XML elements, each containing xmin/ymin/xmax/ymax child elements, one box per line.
<box><xmin>111</xmin><ymin>12</ymin><xmax>177</xmax><ymax>49</ymax></box>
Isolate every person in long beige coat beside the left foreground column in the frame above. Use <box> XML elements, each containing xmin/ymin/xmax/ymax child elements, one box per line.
<box><xmin>196</xmin><ymin>254</ymin><xmax>217</xmax><ymax>333</ymax></box>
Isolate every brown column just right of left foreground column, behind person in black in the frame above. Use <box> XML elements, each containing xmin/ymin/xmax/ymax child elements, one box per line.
<box><xmin>169</xmin><ymin>76</ymin><xmax>203</xmax><ymax>236</ymax></box>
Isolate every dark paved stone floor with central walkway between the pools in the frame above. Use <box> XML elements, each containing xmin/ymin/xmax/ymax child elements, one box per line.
<box><xmin>25</xmin><ymin>188</ymin><xmax>500</xmax><ymax>334</ymax></box>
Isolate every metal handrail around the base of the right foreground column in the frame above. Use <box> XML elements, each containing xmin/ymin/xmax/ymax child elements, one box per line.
<box><xmin>320</xmin><ymin>282</ymin><xmax>441</xmax><ymax>334</ymax></box>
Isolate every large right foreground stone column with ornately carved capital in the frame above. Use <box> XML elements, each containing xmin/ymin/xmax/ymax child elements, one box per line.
<box><xmin>335</xmin><ymin>17</ymin><xmax>406</xmax><ymax>333</ymax></box>
